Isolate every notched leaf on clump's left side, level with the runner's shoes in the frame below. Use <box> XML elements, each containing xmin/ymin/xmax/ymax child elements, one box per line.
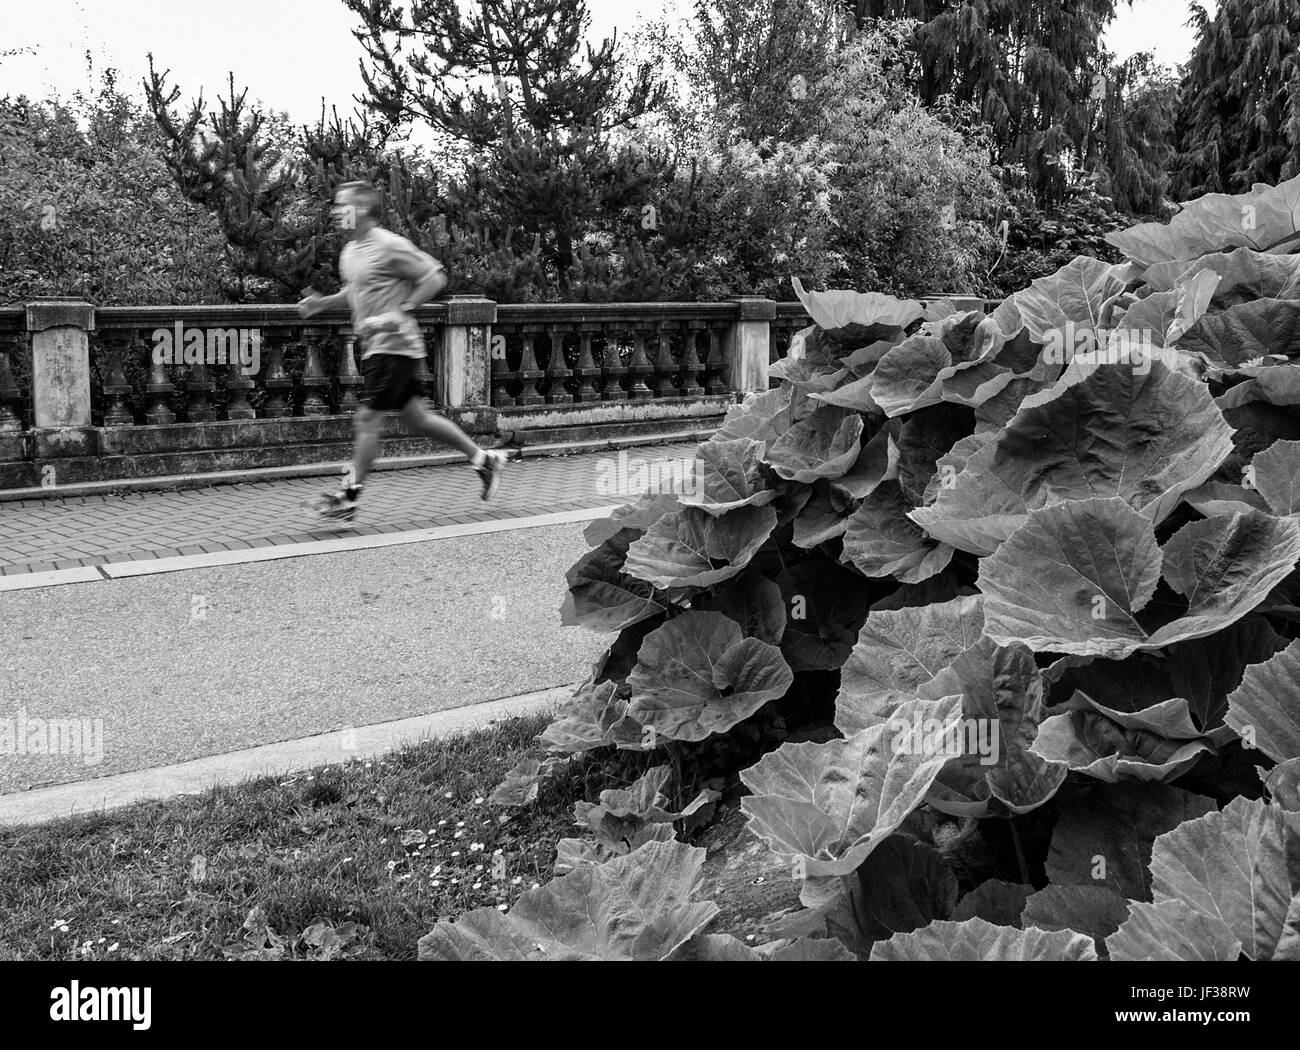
<box><xmin>623</xmin><ymin>507</ymin><xmax>776</xmax><ymax>589</ymax></box>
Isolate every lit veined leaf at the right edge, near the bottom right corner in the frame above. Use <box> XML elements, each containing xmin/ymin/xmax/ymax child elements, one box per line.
<box><xmin>1151</xmin><ymin>798</ymin><xmax>1300</xmax><ymax>960</ymax></box>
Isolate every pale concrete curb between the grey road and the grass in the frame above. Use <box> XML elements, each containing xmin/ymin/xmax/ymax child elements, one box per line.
<box><xmin>0</xmin><ymin>685</ymin><xmax>576</xmax><ymax>826</ymax></box>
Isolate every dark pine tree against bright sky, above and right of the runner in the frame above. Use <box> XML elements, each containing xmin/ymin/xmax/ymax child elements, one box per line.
<box><xmin>345</xmin><ymin>0</ymin><xmax>663</xmax><ymax>290</ymax></box>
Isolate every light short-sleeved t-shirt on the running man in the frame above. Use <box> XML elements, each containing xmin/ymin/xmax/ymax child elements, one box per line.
<box><xmin>338</xmin><ymin>226</ymin><xmax>442</xmax><ymax>360</ymax></box>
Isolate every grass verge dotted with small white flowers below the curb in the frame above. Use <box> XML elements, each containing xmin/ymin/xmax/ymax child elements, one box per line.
<box><xmin>0</xmin><ymin>715</ymin><xmax>637</xmax><ymax>960</ymax></box>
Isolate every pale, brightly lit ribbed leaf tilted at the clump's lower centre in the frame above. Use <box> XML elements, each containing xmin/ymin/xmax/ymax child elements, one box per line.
<box><xmin>741</xmin><ymin>697</ymin><xmax>961</xmax><ymax>878</ymax></box>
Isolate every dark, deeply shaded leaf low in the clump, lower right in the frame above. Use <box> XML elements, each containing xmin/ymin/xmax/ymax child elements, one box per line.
<box><xmin>1047</xmin><ymin>782</ymin><xmax>1216</xmax><ymax>901</ymax></box>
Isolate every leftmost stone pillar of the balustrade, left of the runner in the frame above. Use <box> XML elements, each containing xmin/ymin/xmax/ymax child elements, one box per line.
<box><xmin>25</xmin><ymin>298</ymin><xmax>95</xmax><ymax>428</ymax></box>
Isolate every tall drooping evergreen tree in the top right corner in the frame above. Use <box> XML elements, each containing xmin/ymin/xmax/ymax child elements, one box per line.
<box><xmin>1175</xmin><ymin>0</ymin><xmax>1300</xmax><ymax>200</ymax></box>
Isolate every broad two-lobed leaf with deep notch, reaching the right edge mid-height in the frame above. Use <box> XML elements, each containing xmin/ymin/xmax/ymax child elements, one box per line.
<box><xmin>979</xmin><ymin>499</ymin><xmax>1300</xmax><ymax>659</ymax></box>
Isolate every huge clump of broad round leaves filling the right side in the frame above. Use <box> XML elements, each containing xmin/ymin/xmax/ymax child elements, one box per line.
<box><xmin>421</xmin><ymin>178</ymin><xmax>1300</xmax><ymax>959</ymax></box>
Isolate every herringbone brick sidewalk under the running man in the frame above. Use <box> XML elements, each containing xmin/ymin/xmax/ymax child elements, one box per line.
<box><xmin>0</xmin><ymin>443</ymin><xmax>696</xmax><ymax>576</ymax></box>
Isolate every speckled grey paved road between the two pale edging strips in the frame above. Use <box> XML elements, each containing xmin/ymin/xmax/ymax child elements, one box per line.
<box><xmin>0</xmin><ymin>519</ymin><xmax>611</xmax><ymax>793</ymax></box>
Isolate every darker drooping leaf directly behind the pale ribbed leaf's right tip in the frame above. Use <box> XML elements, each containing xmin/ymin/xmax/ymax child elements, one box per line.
<box><xmin>915</xmin><ymin>638</ymin><xmax>1069</xmax><ymax>817</ymax></box>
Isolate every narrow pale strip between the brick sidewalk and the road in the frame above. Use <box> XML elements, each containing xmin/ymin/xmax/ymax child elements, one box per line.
<box><xmin>0</xmin><ymin>503</ymin><xmax>620</xmax><ymax>591</ymax></box>
